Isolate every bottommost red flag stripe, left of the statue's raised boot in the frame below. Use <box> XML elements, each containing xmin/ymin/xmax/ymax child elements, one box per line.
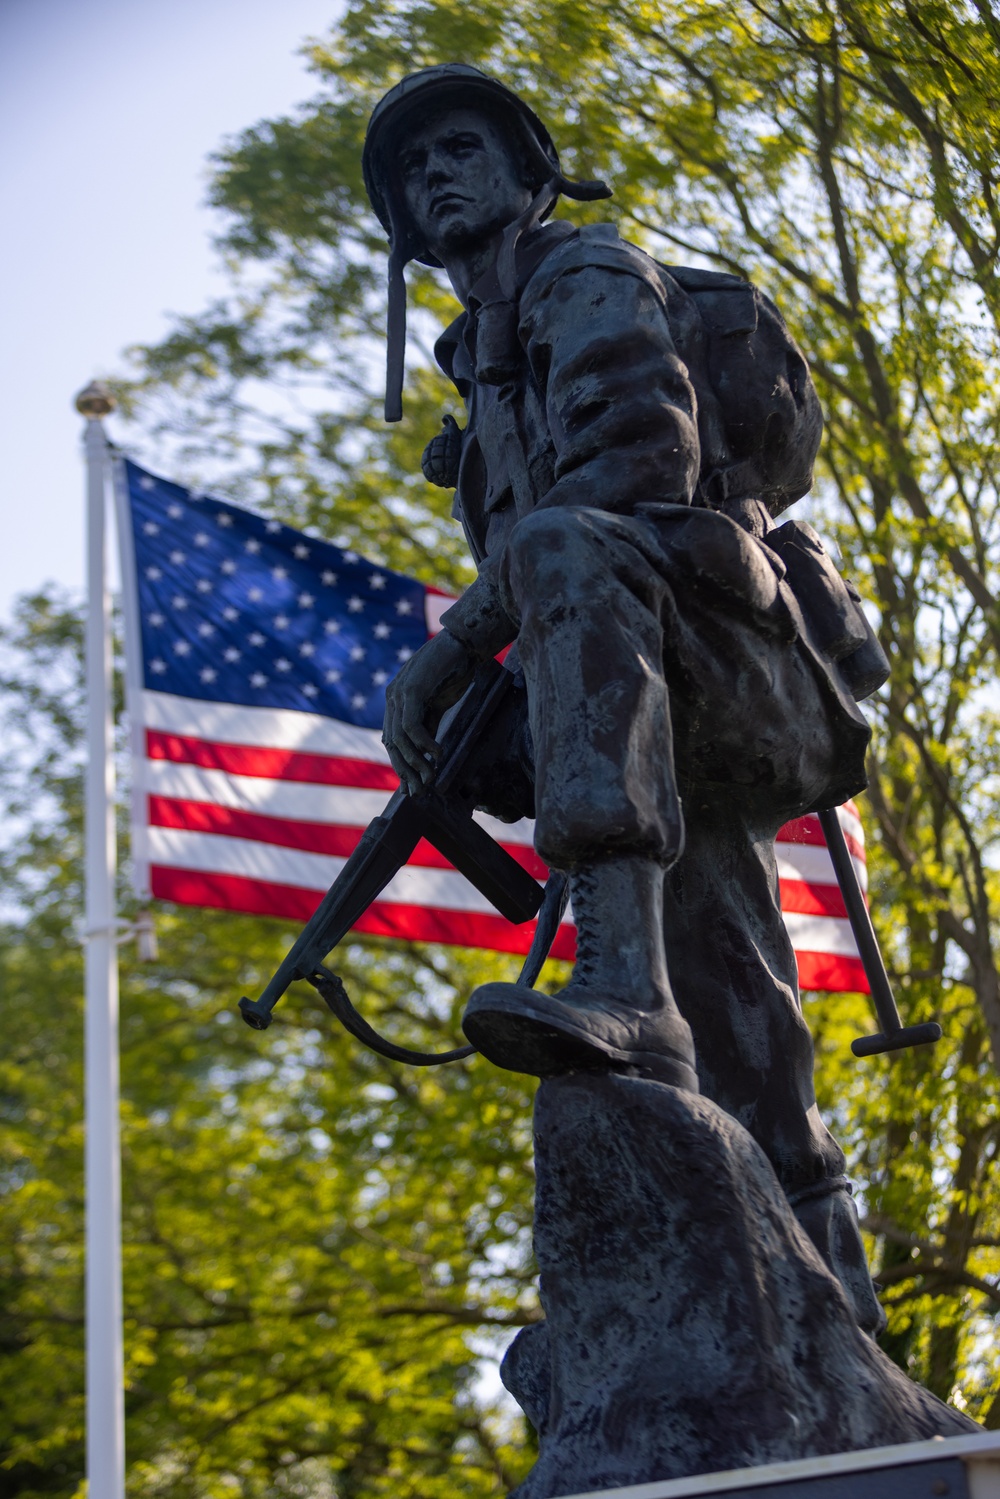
<box><xmin>150</xmin><ymin>865</ymin><xmax>576</xmax><ymax>959</ymax></box>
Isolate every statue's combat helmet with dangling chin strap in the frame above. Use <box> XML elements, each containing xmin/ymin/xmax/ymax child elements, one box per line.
<box><xmin>361</xmin><ymin>63</ymin><xmax>610</xmax><ymax>421</ymax></box>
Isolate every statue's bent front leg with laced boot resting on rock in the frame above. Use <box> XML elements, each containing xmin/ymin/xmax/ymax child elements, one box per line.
<box><xmin>463</xmin><ymin>508</ymin><xmax>697</xmax><ymax>1090</ymax></box>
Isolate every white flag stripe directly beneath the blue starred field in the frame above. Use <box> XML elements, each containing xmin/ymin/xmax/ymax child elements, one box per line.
<box><xmin>142</xmin><ymin>691</ymin><xmax>388</xmax><ymax>764</ymax></box>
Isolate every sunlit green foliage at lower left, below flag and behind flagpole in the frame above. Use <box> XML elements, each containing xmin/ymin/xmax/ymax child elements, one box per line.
<box><xmin>0</xmin><ymin>597</ymin><xmax>538</xmax><ymax>1499</ymax></box>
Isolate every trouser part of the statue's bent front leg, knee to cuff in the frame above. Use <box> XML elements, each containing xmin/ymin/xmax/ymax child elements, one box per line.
<box><xmin>507</xmin><ymin>508</ymin><xmax>684</xmax><ymax>869</ymax></box>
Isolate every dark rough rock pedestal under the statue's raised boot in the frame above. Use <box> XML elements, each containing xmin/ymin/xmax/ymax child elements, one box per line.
<box><xmin>501</xmin><ymin>1072</ymin><xmax>979</xmax><ymax>1499</ymax></box>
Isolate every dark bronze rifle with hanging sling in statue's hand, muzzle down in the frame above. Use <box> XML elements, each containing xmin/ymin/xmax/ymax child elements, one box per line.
<box><xmin>240</xmin><ymin>661</ymin><xmax>567</xmax><ymax>1066</ymax></box>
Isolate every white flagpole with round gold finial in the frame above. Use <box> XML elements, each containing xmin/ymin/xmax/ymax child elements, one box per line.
<box><xmin>76</xmin><ymin>381</ymin><xmax>124</xmax><ymax>1499</ymax></box>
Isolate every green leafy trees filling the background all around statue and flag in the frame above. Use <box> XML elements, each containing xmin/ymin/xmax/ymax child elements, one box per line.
<box><xmin>0</xmin><ymin>0</ymin><xmax>1000</xmax><ymax>1496</ymax></box>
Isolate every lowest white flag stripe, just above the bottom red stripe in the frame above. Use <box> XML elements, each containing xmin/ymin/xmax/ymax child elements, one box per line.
<box><xmin>150</xmin><ymin>827</ymin><xmax>509</xmax><ymax>916</ymax></box>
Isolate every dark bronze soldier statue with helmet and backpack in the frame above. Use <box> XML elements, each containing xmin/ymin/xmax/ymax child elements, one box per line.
<box><xmin>364</xmin><ymin>64</ymin><xmax>888</xmax><ymax>1333</ymax></box>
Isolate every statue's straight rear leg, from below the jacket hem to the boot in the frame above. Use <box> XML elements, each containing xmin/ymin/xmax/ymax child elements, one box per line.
<box><xmin>664</xmin><ymin>809</ymin><xmax>885</xmax><ymax>1333</ymax></box>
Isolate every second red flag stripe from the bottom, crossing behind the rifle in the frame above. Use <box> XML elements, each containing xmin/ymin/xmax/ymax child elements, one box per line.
<box><xmin>148</xmin><ymin>796</ymin><xmax>549</xmax><ymax>880</ymax></box>
